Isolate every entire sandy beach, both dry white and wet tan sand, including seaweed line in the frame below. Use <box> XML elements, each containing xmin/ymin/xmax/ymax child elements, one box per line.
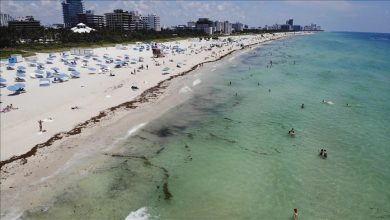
<box><xmin>1</xmin><ymin>31</ymin><xmax>310</xmax><ymax>216</ymax></box>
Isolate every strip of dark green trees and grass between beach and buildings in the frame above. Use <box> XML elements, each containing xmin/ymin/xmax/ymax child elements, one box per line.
<box><xmin>0</xmin><ymin>27</ymin><xmax>292</xmax><ymax>58</ymax></box>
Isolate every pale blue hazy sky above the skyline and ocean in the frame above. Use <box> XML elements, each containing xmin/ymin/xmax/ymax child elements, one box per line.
<box><xmin>0</xmin><ymin>0</ymin><xmax>390</xmax><ymax>33</ymax></box>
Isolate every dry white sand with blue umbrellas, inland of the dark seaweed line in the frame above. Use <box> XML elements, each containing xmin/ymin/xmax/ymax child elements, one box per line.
<box><xmin>1</xmin><ymin>33</ymin><xmax>304</xmax><ymax>161</ymax></box>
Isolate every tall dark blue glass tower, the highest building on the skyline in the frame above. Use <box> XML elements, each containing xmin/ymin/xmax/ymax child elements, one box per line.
<box><xmin>62</xmin><ymin>0</ymin><xmax>84</xmax><ymax>27</ymax></box>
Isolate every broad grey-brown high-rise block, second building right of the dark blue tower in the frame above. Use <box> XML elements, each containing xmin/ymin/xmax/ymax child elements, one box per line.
<box><xmin>104</xmin><ymin>9</ymin><xmax>131</xmax><ymax>31</ymax></box>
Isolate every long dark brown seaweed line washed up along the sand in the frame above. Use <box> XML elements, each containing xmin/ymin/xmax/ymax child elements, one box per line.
<box><xmin>0</xmin><ymin>37</ymin><xmax>270</xmax><ymax>170</ymax></box>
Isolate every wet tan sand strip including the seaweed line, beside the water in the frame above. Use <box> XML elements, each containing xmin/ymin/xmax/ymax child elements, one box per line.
<box><xmin>0</xmin><ymin>31</ymin><xmax>310</xmax><ymax>217</ymax></box>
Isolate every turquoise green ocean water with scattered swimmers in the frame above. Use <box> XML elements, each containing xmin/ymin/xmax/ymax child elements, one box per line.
<box><xmin>23</xmin><ymin>33</ymin><xmax>390</xmax><ymax>220</ymax></box>
